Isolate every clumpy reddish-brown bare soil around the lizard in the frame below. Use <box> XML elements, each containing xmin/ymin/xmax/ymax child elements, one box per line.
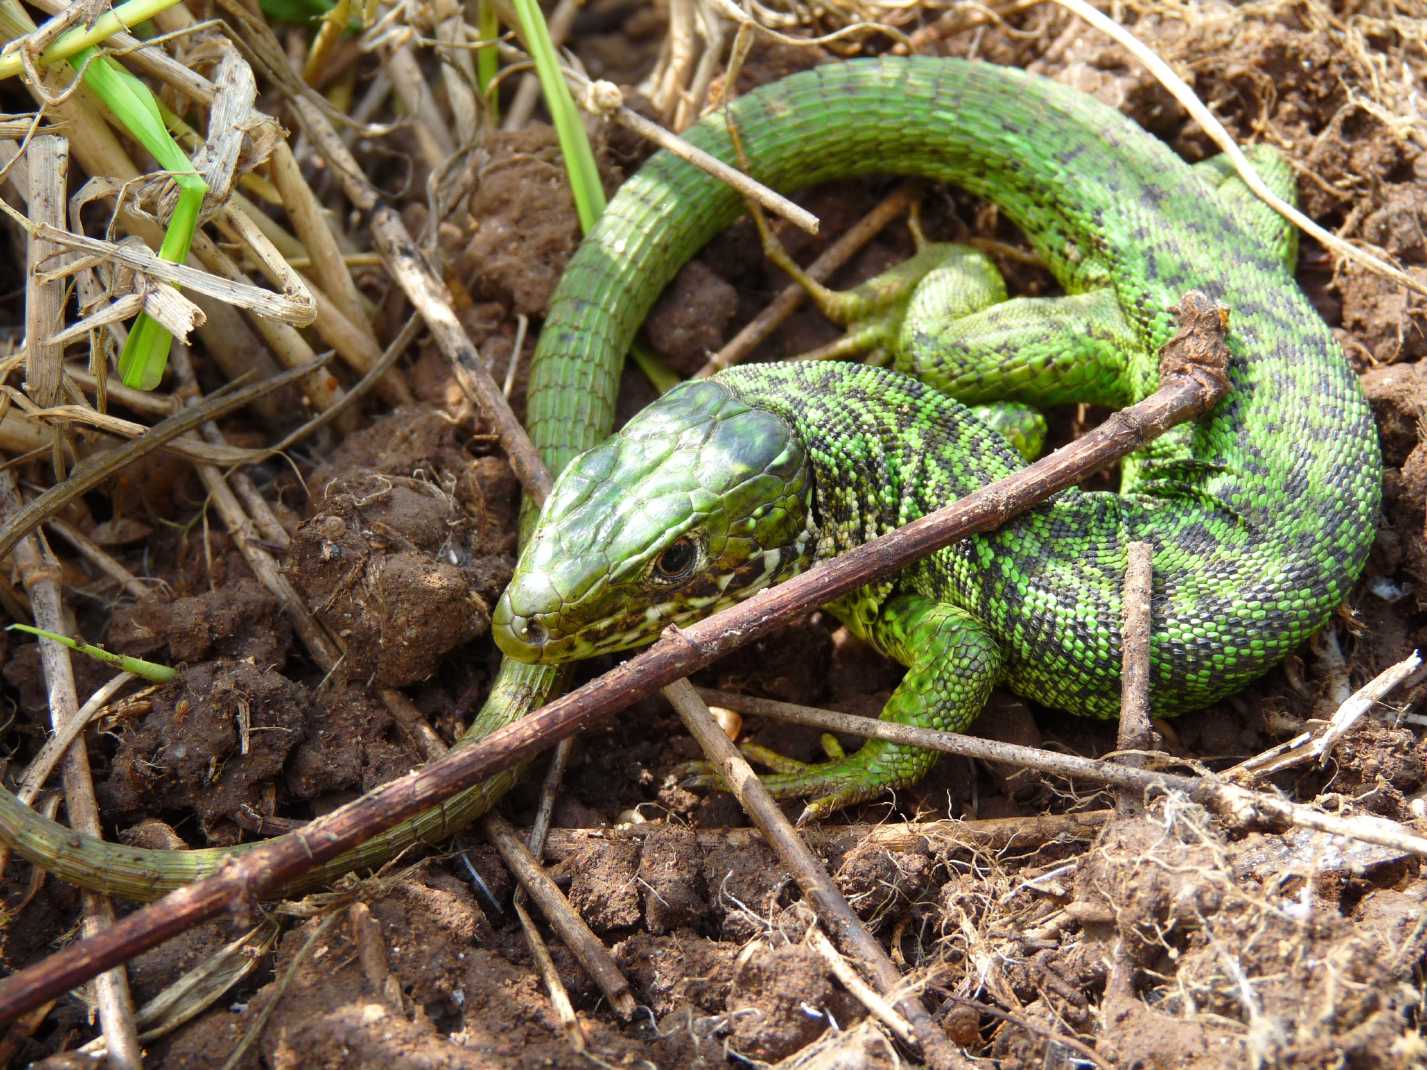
<box><xmin>0</xmin><ymin>0</ymin><xmax>1427</xmax><ymax>1070</ymax></box>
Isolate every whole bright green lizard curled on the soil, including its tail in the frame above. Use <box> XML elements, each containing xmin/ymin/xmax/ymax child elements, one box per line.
<box><xmin>0</xmin><ymin>58</ymin><xmax>1380</xmax><ymax>899</ymax></box>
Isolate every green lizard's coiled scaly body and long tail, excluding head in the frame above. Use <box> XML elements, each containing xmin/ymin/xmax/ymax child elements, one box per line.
<box><xmin>0</xmin><ymin>58</ymin><xmax>1380</xmax><ymax>897</ymax></box>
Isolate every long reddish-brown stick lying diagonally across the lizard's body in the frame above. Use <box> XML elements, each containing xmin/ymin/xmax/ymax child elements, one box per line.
<box><xmin>0</xmin><ymin>341</ymin><xmax>1227</xmax><ymax>1020</ymax></box>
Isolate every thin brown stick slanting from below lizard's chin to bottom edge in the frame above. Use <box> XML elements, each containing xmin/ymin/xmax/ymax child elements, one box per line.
<box><xmin>664</xmin><ymin>681</ymin><xmax>949</xmax><ymax>1063</ymax></box>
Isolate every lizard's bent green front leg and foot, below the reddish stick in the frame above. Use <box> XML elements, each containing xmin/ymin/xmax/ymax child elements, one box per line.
<box><xmin>762</xmin><ymin>595</ymin><xmax>1005</xmax><ymax>823</ymax></box>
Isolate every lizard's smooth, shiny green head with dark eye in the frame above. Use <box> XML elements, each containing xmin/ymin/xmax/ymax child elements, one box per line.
<box><xmin>491</xmin><ymin>382</ymin><xmax>815</xmax><ymax>662</ymax></box>
